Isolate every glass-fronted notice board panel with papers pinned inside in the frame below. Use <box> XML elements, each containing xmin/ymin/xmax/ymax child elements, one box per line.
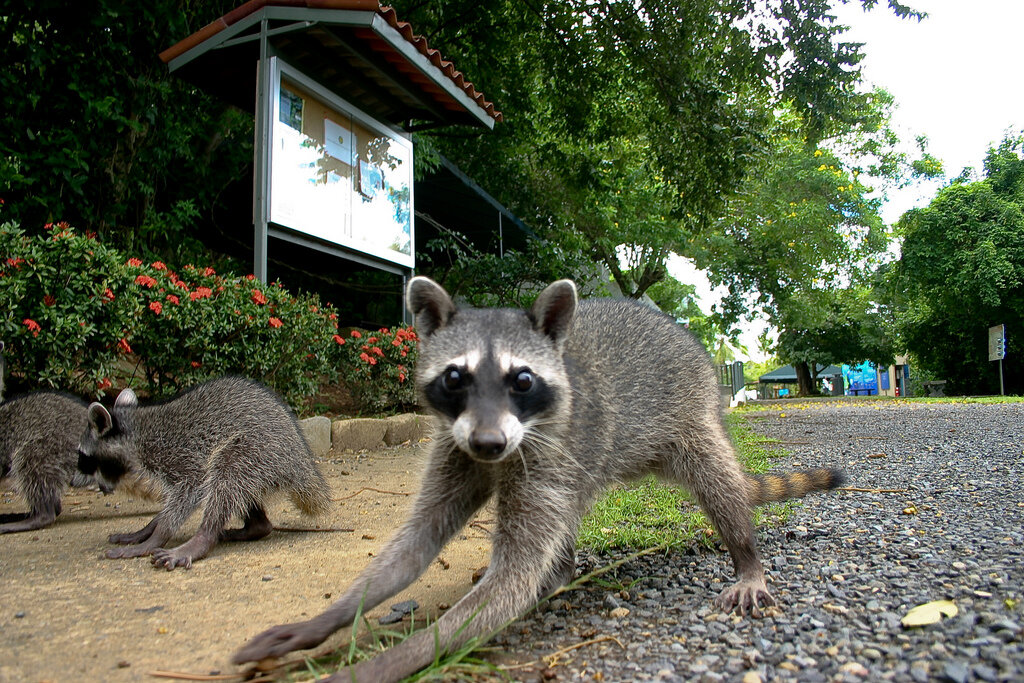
<box><xmin>268</xmin><ymin>60</ymin><xmax>415</xmax><ymax>268</ymax></box>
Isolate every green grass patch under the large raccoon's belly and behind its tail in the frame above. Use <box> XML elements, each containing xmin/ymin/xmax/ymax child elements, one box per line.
<box><xmin>579</xmin><ymin>414</ymin><xmax>798</xmax><ymax>551</ymax></box>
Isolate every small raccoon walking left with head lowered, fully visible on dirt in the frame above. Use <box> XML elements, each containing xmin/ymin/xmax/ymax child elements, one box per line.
<box><xmin>78</xmin><ymin>377</ymin><xmax>331</xmax><ymax>569</ymax></box>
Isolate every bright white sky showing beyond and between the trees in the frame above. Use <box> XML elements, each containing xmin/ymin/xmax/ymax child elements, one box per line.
<box><xmin>669</xmin><ymin>0</ymin><xmax>1024</xmax><ymax>360</ymax></box>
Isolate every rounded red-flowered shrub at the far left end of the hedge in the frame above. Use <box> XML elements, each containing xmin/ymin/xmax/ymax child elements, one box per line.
<box><xmin>0</xmin><ymin>223</ymin><xmax>139</xmax><ymax>395</ymax></box>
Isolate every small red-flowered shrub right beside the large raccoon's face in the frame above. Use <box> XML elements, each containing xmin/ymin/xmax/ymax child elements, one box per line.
<box><xmin>332</xmin><ymin>327</ymin><xmax>419</xmax><ymax>410</ymax></box>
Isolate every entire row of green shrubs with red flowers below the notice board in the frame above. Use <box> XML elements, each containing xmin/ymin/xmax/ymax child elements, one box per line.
<box><xmin>0</xmin><ymin>219</ymin><xmax>417</xmax><ymax>411</ymax></box>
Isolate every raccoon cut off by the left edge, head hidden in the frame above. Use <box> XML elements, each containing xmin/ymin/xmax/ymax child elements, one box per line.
<box><xmin>0</xmin><ymin>342</ymin><xmax>117</xmax><ymax>533</ymax></box>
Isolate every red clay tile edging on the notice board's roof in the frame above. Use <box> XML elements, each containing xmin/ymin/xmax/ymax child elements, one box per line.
<box><xmin>160</xmin><ymin>0</ymin><xmax>503</xmax><ymax>121</ymax></box>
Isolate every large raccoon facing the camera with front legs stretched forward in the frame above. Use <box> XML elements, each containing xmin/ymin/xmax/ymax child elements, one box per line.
<box><xmin>234</xmin><ymin>278</ymin><xmax>841</xmax><ymax>681</ymax></box>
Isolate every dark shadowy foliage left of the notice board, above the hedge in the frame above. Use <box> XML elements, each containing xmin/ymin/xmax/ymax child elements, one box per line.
<box><xmin>0</xmin><ymin>0</ymin><xmax>252</xmax><ymax>258</ymax></box>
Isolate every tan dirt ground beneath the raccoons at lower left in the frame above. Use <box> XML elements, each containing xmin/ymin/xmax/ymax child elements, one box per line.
<box><xmin>0</xmin><ymin>444</ymin><xmax>490</xmax><ymax>683</ymax></box>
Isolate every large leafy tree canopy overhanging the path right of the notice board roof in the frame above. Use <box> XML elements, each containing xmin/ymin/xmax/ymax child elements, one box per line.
<box><xmin>398</xmin><ymin>0</ymin><xmax>921</xmax><ymax>297</ymax></box>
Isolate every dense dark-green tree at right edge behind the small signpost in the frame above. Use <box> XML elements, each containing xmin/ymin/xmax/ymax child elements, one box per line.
<box><xmin>888</xmin><ymin>134</ymin><xmax>1024</xmax><ymax>393</ymax></box>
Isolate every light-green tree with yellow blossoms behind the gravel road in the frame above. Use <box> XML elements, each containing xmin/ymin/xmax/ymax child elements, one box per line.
<box><xmin>694</xmin><ymin>91</ymin><xmax>912</xmax><ymax>393</ymax></box>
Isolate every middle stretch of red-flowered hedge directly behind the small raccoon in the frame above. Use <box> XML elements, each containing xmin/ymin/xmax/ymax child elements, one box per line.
<box><xmin>127</xmin><ymin>258</ymin><xmax>337</xmax><ymax>404</ymax></box>
